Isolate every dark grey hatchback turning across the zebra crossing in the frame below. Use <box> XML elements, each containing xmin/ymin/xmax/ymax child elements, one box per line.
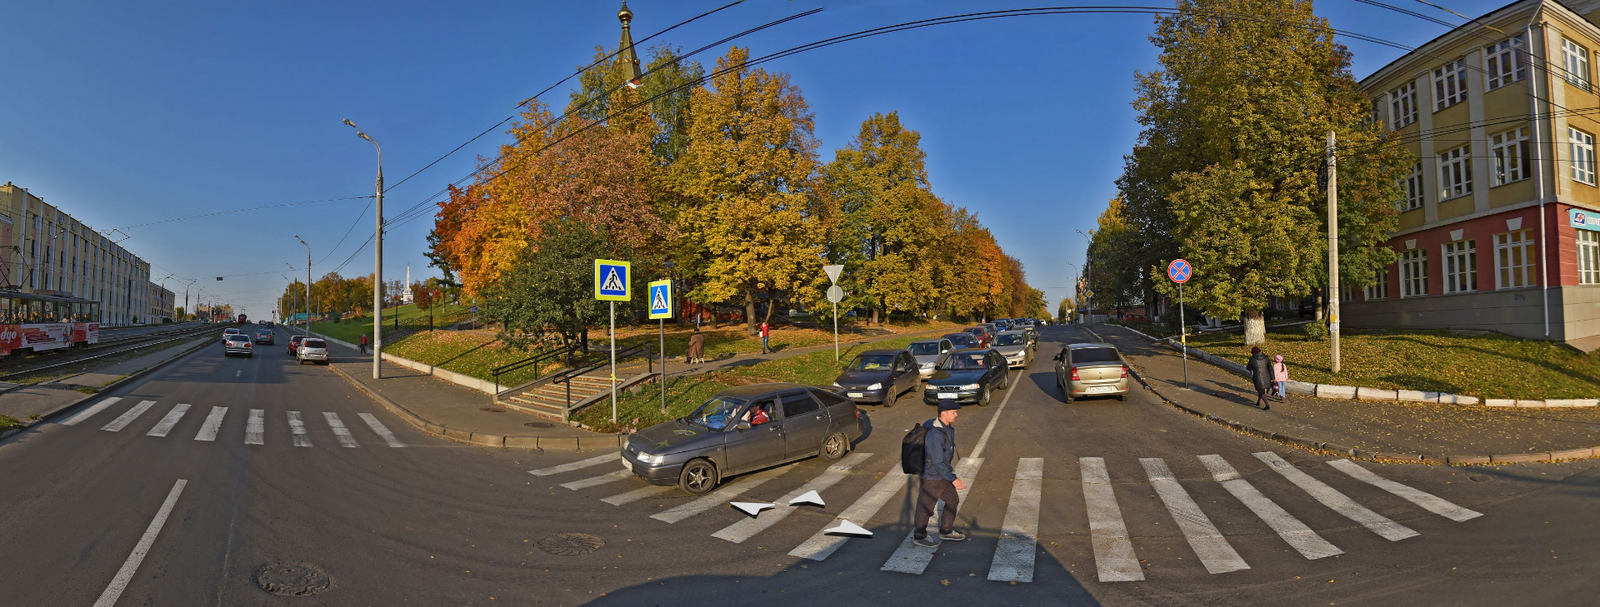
<box><xmin>622</xmin><ymin>383</ymin><xmax>864</xmax><ymax>495</ymax></box>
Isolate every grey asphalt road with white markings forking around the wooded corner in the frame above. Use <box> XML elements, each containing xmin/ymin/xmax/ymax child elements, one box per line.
<box><xmin>0</xmin><ymin>327</ymin><xmax>1600</xmax><ymax>605</ymax></box>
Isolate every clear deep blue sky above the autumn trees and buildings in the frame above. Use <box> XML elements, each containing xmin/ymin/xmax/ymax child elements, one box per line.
<box><xmin>0</xmin><ymin>0</ymin><xmax>1504</xmax><ymax>317</ymax></box>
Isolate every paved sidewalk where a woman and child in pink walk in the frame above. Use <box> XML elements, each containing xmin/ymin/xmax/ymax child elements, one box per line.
<box><xmin>1091</xmin><ymin>325</ymin><xmax>1600</xmax><ymax>464</ymax></box>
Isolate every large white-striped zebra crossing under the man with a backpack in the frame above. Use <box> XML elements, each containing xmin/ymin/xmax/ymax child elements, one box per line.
<box><xmin>528</xmin><ymin>452</ymin><xmax>1483</xmax><ymax>583</ymax></box>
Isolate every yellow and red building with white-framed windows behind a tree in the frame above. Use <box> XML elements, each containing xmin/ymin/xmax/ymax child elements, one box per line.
<box><xmin>1341</xmin><ymin>0</ymin><xmax>1600</xmax><ymax>351</ymax></box>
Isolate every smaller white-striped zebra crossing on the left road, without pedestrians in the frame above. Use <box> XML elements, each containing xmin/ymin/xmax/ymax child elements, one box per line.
<box><xmin>61</xmin><ymin>397</ymin><xmax>405</xmax><ymax>448</ymax></box>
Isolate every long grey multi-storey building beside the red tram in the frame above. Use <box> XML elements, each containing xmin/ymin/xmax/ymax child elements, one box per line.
<box><xmin>0</xmin><ymin>181</ymin><xmax>152</xmax><ymax>325</ymax></box>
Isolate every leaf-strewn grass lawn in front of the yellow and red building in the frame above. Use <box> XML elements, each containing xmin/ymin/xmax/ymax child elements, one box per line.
<box><xmin>1189</xmin><ymin>327</ymin><xmax>1600</xmax><ymax>399</ymax></box>
